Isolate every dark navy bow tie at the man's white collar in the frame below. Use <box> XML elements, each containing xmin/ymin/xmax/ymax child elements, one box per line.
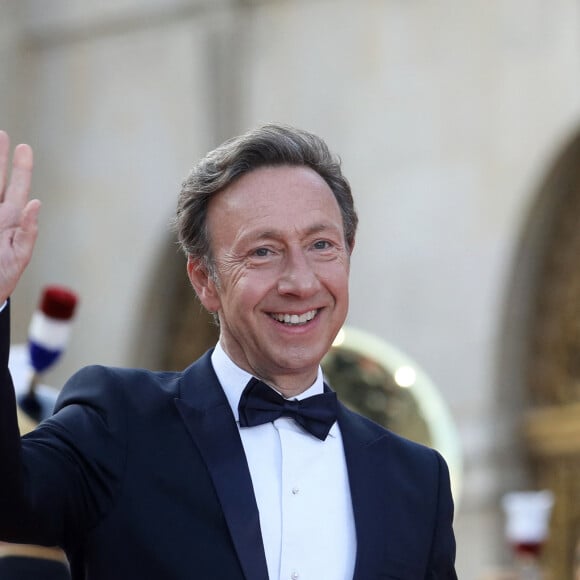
<box><xmin>238</xmin><ymin>378</ymin><xmax>337</xmax><ymax>441</ymax></box>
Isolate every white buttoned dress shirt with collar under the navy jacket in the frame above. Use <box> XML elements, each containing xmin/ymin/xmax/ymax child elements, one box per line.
<box><xmin>211</xmin><ymin>344</ymin><xmax>356</xmax><ymax>580</ymax></box>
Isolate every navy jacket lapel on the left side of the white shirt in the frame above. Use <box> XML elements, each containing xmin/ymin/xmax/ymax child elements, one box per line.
<box><xmin>175</xmin><ymin>352</ymin><xmax>268</xmax><ymax>580</ymax></box>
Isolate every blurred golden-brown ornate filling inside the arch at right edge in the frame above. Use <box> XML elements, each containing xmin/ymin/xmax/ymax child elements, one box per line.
<box><xmin>524</xmin><ymin>131</ymin><xmax>580</xmax><ymax>580</ymax></box>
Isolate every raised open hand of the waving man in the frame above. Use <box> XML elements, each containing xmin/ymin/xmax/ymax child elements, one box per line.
<box><xmin>0</xmin><ymin>131</ymin><xmax>40</xmax><ymax>305</ymax></box>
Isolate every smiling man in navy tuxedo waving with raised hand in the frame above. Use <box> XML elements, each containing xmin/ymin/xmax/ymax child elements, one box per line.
<box><xmin>0</xmin><ymin>125</ymin><xmax>456</xmax><ymax>580</ymax></box>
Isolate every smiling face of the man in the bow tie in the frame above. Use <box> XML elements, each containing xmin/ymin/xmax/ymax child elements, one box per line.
<box><xmin>188</xmin><ymin>166</ymin><xmax>350</xmax><ymax>390</ymax></box>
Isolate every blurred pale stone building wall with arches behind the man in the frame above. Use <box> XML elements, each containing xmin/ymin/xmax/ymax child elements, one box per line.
<box><xmin>0</xmin><ymin>0</ymin><xmax>580</xmax><ymax>580</ymax></box>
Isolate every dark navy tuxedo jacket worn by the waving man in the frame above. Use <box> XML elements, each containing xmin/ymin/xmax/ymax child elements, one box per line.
<box><xmin>0</xmin><ymin>309</ymin><xmax>456</xmax><ymax>580</ymax></box>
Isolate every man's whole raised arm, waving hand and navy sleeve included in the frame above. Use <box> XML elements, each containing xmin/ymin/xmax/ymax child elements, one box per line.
<box><xmin>0</xmin><ymin>131</ymin><xmax>125</xmax><ymax>547</ymax></box>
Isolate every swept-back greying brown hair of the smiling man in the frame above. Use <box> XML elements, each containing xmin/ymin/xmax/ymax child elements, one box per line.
<box><xmin>174</xmin><ymin>124</ymin><xmax>358</xmax><ymax>272</ymax></box>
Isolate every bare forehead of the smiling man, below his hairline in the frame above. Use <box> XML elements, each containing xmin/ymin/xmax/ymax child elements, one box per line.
<box><xmin>208</xmin><ymin>166</ymin><xmax>342</xmax><ymax>239</ymax></box>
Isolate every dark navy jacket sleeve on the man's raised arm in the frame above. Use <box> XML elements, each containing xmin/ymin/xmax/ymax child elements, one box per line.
<box><xmin>0</xmin><ymin>302</ymin><xmax>126</xmax><ymax>549</ymax></box>
